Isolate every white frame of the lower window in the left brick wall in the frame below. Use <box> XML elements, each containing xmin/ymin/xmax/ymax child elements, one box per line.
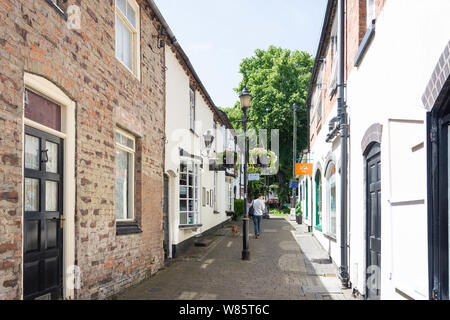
<box><xmin>114</xmin><ymin>128</ymin><xmax>136</xmax><ymax>222</ymax></box>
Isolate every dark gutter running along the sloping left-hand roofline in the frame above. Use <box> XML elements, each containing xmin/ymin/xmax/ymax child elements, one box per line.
<box><xmin>147</xmin><ymin>0</ymin><xmax>229</xmax><ymax>126</ymax></box>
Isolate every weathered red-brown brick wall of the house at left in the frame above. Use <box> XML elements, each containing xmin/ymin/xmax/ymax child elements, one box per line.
<box><xmin>0</xmin><ymin>0</ymin><xmax>165</xmax><ymax>299</ymax></box>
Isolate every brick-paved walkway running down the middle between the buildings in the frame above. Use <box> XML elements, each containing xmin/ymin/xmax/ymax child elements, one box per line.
<box><xmin>114</xmin><ymin>218</ymin><xmax>351</xmax><ymax>300</ymax></box>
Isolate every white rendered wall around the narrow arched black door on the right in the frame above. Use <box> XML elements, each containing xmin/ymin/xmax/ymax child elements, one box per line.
<box><xmin>347</xmin><ymin>0</ymin><xmax>450</xmax><ymax>299</ymax></box>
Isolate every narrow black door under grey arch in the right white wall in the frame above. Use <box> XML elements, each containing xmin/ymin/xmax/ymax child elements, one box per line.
<box><xmin>366</xmin><ymin>144</ymin><xmax>381</xmax><ymax>300</ymax></box>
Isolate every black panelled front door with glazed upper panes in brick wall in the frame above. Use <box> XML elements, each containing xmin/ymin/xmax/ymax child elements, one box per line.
<box><xmin>23</xmin><ymin>127</ymin><xmax>63</xmax><ymax>300</ymax></box>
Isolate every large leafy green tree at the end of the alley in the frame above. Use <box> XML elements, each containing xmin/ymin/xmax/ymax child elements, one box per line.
<box><xmin>223</xmin><ymin>46</ymin><xmax>314</xmax><ymax>203</ymax></box>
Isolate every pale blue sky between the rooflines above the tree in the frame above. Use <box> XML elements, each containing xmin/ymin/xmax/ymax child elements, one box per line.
<box><xmin>155</xmin><ymin>0</ymin><xmax>327</xmax><ymax>107</ymax></box>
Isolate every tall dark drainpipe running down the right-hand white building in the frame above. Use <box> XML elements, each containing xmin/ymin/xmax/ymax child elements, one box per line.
<box><xmin>337</xmin><ymin>0</ymin><xmax>349</xmax><ymax>288</ymax></box>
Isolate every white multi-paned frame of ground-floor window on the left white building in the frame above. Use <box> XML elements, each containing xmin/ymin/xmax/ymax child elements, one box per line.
<box><xmin>178</xmin><ymin>158</ymin><xmax>201</xmax><ymax>227</ymax></box>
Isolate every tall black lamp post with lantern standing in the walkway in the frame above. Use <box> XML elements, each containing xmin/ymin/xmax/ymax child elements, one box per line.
<box><xmin>239</xmin><ymin>86</ymin><xmax>252</xmax><ymax>261</ymax></box>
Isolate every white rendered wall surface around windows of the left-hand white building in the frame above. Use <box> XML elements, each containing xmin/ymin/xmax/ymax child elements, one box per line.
<box><xmin>165</xmin><ymin>46</ymin><xmax>227</xmax><ymax>249</ymax></box>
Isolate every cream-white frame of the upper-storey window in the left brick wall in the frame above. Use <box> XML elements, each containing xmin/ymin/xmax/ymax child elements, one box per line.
<box><xmin>114</xmin><ymin>0</ymin><xmax>141</xmax><ymax>80</ymax></box>
